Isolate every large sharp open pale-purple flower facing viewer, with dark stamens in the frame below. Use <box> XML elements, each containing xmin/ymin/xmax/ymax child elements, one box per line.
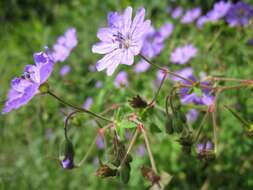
<box><xmin>92</xmin><ymin>7</ymin><xmax>151</xmax><ymax>76</ymax></box>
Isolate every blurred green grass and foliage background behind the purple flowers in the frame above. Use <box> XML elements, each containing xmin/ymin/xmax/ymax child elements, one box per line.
<box><xmin>0</xmin><ymin>0</ymin><xmax>253</xmax><ymax>189</ymax></box>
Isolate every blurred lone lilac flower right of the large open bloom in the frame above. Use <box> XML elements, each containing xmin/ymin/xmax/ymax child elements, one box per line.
<box><xmin>170</xmin><ymin>44</ymin><xmax>197</xmax><ymax>64</ymax></box>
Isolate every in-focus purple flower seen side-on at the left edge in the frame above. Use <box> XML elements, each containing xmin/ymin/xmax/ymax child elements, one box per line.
<box><xmin>2</xmin><ymin>52</ymin><xmax>54</xmax><ymax>113</ymax></box>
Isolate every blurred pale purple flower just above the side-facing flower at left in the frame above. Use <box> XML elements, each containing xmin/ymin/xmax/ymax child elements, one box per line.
<box><xmin>51</xmin><ymin>28</ymin><xmax>77</xmax><ymax>62</ymax></box>
